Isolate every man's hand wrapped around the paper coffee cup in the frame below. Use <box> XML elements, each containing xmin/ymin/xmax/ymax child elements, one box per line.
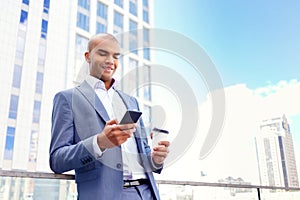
<box><xmin>152</xmin><ymin>141</ymin><xmax>170</xmax><ymax>165</ymax></box>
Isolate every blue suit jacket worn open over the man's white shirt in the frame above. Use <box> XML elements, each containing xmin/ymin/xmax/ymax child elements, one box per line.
<box><xmin>50</xmin><ymin>81</ymin><xmax>161</xmax><ymax>200</ymax></box>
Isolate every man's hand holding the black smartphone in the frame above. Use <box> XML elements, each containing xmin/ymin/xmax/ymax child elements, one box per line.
<box><xmin>97</xmin><ymin>119</ymin><xmax>137</xmax><ymax>151</ymax></box>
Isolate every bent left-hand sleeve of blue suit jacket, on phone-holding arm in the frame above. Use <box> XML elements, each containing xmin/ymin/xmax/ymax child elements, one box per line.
<box><xmin>49</xmin><ymin>92</ymin><xmax>95</xmax><ymax>173</ymax></box>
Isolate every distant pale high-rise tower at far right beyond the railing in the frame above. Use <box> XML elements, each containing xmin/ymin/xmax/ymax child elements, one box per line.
<box><xmin>256</xmin><ymin>115</ymin><xmax>299</xmax><ymax>187</ymax></box>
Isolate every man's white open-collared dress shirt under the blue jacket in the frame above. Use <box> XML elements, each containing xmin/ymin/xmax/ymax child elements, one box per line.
<box><xmin>86</xmin><ymin>75</ymin><xmax>146</xmax><ymax>180</ymax></box>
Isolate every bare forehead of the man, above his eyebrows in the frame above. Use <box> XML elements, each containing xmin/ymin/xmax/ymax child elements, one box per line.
<box><xmin>90</xmin><ymin>37</ymin><xmax>120</xmax><ymax>53</ymax></box>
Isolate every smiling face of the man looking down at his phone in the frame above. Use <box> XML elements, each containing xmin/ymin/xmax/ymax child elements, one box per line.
<box><xmin>85</xmin><ymin>38</ymin><xmax>120</xmax><ymax>82</ymax></box>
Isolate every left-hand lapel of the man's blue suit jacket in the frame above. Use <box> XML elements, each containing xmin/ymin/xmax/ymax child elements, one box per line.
<box><xmin>76</xmin><ymin>81</ymin><xmax>109</xmax><ymax>122</ymax></box>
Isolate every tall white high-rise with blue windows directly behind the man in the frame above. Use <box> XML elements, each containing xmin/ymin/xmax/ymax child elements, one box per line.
<box><xmin>0</xmin><ymin>0</ymin><xmax>153</xmax><ymax>171</ymax></box>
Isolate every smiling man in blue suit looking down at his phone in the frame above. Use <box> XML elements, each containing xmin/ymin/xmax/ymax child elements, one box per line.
<box><xmin>50</xmin><ymin>33</ymin><xmax>169</xmax><ymax>200</ymax></box>
